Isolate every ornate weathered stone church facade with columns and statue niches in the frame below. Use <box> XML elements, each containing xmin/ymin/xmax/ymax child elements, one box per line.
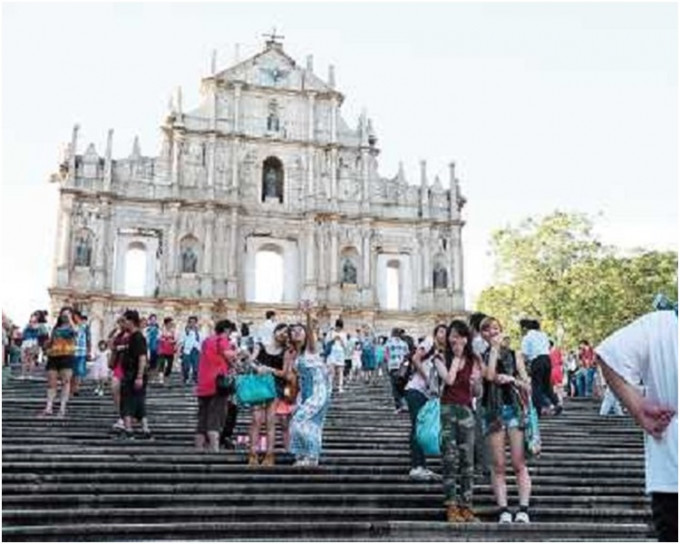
<box><xmin>50</xmin><ymin>39</ymin><xmax>465</xmax><ymax>344</ymax></box>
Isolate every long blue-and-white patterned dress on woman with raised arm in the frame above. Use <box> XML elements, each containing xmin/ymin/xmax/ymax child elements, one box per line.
<box><xmin>290</xmin><ymin>353</ymin><xmax>331</xmax><ymax>461</ymax></box>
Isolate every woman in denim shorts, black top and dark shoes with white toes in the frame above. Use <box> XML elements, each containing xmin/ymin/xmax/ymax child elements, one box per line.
<box><xmin>480</xmin><ymin>317</ymin><xmax>531</xmax><ymax>523</ymax></box>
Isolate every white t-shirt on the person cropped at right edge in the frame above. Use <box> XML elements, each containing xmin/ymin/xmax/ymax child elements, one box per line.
<box><xmin>595</xmin><ymin>311</ymin><xmax>678</xmax><ymax>493</ymax></box>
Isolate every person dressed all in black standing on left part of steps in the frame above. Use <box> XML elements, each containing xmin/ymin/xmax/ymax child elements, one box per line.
<box><xmin>120</xmin><ymin>310</ymin><xmax>151</xmax><ymax>438</ymax></box>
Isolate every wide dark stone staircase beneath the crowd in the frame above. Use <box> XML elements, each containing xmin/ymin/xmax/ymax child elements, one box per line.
<box><xmin>2</xmin><ymin>376</ymin><xmax>653</xmax><ymax>541</ymax></box>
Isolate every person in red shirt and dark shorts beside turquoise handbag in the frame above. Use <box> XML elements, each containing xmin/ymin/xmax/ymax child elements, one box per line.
<box><xmin>195</xmin><ymin>319</ymin><xmax>236</xmax><ymax>452</ymax></box>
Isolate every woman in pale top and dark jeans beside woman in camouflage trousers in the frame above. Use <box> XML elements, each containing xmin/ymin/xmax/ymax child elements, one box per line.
<box><xmin>404</xmin><ymin>324</ymin><xmax>446</xmax><ymax>480</ymax></box>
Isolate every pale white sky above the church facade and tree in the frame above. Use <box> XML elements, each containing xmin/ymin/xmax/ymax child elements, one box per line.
<box><xmin>0</xmin><ymin>2</ymin><xmax>678</xmax><ymax>321</ymax></box>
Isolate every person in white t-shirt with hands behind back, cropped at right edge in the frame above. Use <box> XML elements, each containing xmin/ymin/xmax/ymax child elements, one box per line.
<box><xmin>595</xmin><ymin>310</ymin><xmax>678</xmax><ymax>542</ymax></box>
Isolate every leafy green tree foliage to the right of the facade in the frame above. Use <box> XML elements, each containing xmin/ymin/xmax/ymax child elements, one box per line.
<box><xmin>477</xmin><ymin>211</ymin><xmax>678</xmax><ymax>347</ymax></box>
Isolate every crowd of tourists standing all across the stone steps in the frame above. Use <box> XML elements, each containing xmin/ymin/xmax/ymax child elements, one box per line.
<box><xmin>3</xmin><ymin>302</ymin><xmax>677</xmax><ymax>534</ymax></box>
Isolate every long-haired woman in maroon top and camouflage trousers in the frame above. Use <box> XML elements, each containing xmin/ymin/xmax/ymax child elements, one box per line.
<box><xmin>433</xmin><ymin>319</ymin><xmax>482</xmax><ymax>523</ymax></box>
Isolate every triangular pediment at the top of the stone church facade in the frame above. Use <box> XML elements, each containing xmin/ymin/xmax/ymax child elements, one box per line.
<box><xmin>216</xmin><ymin>46</ymin><xmax>333</xmax><ymax>92</ymax></box>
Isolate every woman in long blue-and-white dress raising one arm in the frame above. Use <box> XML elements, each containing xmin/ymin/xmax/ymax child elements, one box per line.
<box><xmin>290</xmin><ymin>304</ymin><xmax>331</xmax><ymax>466</ymax></box>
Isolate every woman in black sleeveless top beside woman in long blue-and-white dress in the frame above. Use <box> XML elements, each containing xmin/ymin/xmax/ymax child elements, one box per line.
<box><xmin>248</xmin><ymin>323</ymin><xmax>292</xmax><ymax>467</ymax></box>
